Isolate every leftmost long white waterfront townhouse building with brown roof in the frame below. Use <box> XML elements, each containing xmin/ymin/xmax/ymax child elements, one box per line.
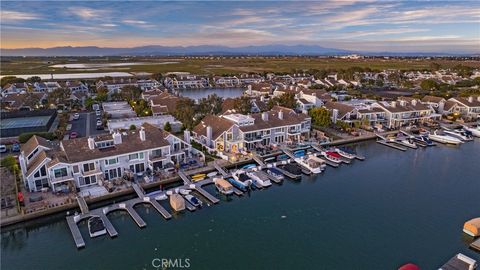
<box><xmin>19</xmin><ymin>124</ymin><xmax>191</xmax><ymax>192</ymax></box>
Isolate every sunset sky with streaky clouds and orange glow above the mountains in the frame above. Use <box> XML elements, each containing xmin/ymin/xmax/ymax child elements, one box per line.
<box><xmin>1</xmin><ymin>0</ymin><xmax>480</xmax><ymax>53</ymax></box>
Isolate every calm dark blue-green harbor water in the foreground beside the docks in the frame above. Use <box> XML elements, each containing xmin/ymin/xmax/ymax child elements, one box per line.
<box><xmin>1</xmin><ymin>139</ymin><xmax>480</xmax><ymax>270</ymax></box>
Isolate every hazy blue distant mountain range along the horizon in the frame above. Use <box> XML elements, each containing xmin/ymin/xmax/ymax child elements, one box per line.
<box><xmin>0</xmin><ymin>45</ymin><xmax>468</xmax><ymax>56</ymax></box>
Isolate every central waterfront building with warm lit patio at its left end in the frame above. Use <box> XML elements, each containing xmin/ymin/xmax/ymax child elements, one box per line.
<box><xmin>192</xmin><ymin>106</ymin><xmax>311</xmax><ymax>153</ymax></box>
